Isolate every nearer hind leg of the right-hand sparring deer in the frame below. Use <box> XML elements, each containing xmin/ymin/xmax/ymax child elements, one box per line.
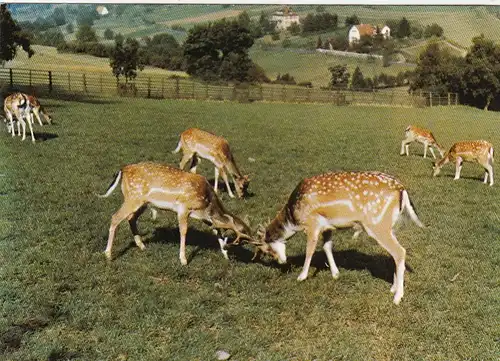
<box><xmin>366</xmin><ymin>227</ymin><xmax>406</xmax><ymax>305</ymax></box>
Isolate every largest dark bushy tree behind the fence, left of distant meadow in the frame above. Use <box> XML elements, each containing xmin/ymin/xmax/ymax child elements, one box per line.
<box><xmin>183</xmin><ymin>19</ymin><xmax>253</xmax><ymax>81</ymax></box>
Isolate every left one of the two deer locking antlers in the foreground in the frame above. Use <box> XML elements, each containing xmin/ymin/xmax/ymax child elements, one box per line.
<box><xmin>99</xmin><ymin>162</ymin><xmax>251</xmax><ymax>265</ymax></box>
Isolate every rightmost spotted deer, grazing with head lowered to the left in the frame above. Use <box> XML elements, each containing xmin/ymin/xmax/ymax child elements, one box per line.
<box><xmin>433</xmin><ymin>140</ymin><xmax>494</xmax><ymax>186</ymax></box>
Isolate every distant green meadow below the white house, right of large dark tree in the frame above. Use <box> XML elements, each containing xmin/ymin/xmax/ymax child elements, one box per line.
<box><xmin>250</xmin><ymin>48</ymin><xmax>414</xmax><ymax>87</ymax></box>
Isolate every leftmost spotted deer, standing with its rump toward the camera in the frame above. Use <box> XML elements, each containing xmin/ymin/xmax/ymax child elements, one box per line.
<box><xmin>3</xmin><ymin>93</ymin><xmax>35</xmax><ymax>143</ymax></box>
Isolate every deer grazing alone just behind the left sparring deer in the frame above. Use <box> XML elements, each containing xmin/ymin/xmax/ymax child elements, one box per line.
<box><xmin>173</xmin><ymin>128</ymin><xmax>249</xmax><ymax>198</ymax></box>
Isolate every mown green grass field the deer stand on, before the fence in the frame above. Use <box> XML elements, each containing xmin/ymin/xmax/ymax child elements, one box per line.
<box><xmin>0</xmin><ymin>98</ymin><xmax>500</xmax><ymax>360</ymax></box>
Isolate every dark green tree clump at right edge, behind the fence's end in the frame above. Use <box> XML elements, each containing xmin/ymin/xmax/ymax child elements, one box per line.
<box><xmin>410</xmin><ymin>35</ymin><xmax>500</xmax><ymax>109</ymax></box>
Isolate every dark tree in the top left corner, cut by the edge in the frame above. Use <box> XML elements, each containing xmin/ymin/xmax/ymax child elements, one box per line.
<box><xmin>0</xmin><ymin>4</ymin><xmax>35</xmax><ymax>66</ymax></box>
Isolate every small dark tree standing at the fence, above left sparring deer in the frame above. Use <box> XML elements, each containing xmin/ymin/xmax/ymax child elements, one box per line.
<box><xmin>109</xmin><ymin>38</ymin><xmax>144</xmax><ymax>83</ymax></box>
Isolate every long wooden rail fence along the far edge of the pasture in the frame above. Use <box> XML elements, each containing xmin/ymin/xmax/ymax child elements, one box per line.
<box><xmin>0</xmin><ymin>68</ymin><xmax>458</xmax><ymax>107</ymax></box>
